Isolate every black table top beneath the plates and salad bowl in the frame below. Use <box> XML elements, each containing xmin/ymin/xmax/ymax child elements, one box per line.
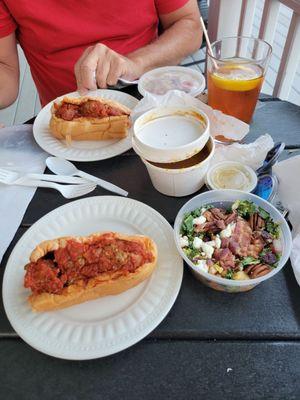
<box><xmin>0</xmin><ymin>88</ymin><xmax>300</xmax><ymax>399</ymax></box>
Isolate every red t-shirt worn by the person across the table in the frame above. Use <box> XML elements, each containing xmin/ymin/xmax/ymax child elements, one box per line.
<box><xmin>0</xmin><ymin>0</ymin><xmax>188</xmax><ymax>105</ymax></box>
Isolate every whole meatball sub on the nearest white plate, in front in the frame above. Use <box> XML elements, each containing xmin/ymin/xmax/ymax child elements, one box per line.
<box><xmin>24</xmin><ymin>232</ymin><xmax>157</xmax><ymax>311</ymax></box>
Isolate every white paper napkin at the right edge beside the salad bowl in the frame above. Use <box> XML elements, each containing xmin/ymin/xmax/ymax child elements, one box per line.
<box><xmin>273</xmin><ymin>156</ymin><xmax>300</xmax><ymax>285</ymax></box>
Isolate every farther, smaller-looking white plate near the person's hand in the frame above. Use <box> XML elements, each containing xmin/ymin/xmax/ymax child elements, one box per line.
<box><xmin>33</xmin><ymin>89</ymin><xmax>138</xmax><ymax>161</ymax></box>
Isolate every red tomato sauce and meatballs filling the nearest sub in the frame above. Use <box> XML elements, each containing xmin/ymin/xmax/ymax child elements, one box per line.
<box><xmin>24</xmin><ymin>234</ymin><xmax>153</xmax><ymax>294</ymax></box>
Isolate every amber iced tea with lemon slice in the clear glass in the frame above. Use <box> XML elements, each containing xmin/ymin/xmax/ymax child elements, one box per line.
<box><xmin>208</xmin><ymin>58</ymin><xmax>263</xmax><ymax>123</ymax></box>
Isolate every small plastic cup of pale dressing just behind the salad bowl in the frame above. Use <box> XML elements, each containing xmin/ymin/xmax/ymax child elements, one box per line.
<box><xmin>206</xmin><ymin>161</ymin><xmax>257</xmax><ymax>192</ymax></box>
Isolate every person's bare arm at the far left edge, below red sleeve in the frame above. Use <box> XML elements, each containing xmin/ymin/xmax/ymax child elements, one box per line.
<box><xmin>0</xmin><ymin>33</ymin><xmax>19</xmax><ymax>109</ymax></box>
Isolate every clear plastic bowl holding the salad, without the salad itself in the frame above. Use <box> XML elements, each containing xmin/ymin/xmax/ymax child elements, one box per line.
<box><xmin>174</xmin><ymin>189</ymin><xmax>292</xmax><ymax>293</ymax></box>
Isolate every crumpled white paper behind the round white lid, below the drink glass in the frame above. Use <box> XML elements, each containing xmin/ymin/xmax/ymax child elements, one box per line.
<box><xmin>131</xmin><ymin>90</ymin><xmax>249</xmax><ymax>141</ymax></box>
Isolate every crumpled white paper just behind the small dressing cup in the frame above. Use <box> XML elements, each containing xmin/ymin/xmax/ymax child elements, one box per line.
<box><xmin>211</xmin><ymin>134</ymin><xmax>274</xmax><ymax>170</ymax></box>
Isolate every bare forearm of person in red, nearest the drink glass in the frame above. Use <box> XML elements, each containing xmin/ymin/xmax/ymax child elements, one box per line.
<box><xmin>127</xmin><ymin>19</ymin><xmax>202</xmax><ymax>75</ymax></box>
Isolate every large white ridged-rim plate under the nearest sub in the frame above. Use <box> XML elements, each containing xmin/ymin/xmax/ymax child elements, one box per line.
<box><xmin>3</xmin><ymin>196</ymin><xmax>183</xmax><ymax>360</ymax></box>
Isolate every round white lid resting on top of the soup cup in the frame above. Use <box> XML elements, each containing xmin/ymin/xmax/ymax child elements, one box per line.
<box><xmin>133</xmin><ymin>106</ymin><xmax>210</xmax><ymax>163</ymax></box>
